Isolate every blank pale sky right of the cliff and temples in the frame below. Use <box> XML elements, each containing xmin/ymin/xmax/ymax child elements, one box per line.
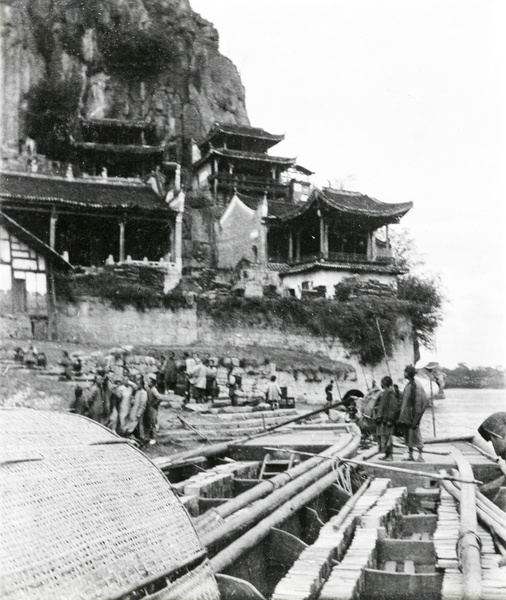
<box><xmin>190</xmin><ymin>0</ymin><xmax>506</xmax><ymax>368</ymax></box>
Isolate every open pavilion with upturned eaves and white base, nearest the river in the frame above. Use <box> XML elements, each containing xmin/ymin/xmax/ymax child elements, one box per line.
<box><xmin>266</xmin><ymin>188</ymin><xmax>413</xmax><ymax>296</ymax></box>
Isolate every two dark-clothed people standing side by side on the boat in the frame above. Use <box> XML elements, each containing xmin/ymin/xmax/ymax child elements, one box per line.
<box><xmin>373</xmin><ymin>365</ymin><xmax>429</xmax><ymax>462</ymax></box>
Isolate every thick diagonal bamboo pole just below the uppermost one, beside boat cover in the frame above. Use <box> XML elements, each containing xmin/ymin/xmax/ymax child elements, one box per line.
<box><xmin>202</xmin><ymin>436</ymin><xmax>360</xmax><ymax>549</ymax></box>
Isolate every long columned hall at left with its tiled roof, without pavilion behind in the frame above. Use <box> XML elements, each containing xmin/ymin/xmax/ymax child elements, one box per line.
<box><xmin>0</xmin><ymin>172</ymin><xmax>181</xmax><ymax>266</ymax></box>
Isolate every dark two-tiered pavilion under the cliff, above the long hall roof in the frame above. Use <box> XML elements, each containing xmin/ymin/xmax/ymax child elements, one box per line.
<box><xmin>71</xmin><ymin>119</ymin><xmax>165</xmax><ymax>178</ymax></box>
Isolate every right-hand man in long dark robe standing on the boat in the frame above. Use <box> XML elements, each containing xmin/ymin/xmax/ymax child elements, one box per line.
<box><xmin>399</xmin><ymin>365</ymin><xmax>429</xmax><ymax>462</ymax></box>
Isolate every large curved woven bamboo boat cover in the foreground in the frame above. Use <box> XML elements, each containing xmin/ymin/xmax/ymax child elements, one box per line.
<box><xmin>0</xmin><ymin>409</ymin><xmax>219</xmax><ymax>600</ymax></box>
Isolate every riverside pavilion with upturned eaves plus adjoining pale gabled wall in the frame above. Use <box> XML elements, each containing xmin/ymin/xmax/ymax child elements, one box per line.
<box><xmin>217</xmin><ymin>188</ymin><xmax>412</xmax><ymax>298</ymax></box>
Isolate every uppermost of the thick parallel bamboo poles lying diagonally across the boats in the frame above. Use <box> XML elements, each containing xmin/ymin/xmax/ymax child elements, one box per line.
<box><xmin>210</xmin><ymin>428</ymin><xmax>360</xmax><ymax>519</ymax></box>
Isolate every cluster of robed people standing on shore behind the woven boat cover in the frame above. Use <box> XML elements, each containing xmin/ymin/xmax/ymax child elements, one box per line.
<box><xmin>72</xmin><ymin>371</ymin><xmax>166</xmax><ymax>445</ymax></box>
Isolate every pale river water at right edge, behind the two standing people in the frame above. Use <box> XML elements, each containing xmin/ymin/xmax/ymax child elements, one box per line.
<box><xmin>422</xmin><ymin>389</ymin><xmax>506</xmax><ymax>437</ymax></box>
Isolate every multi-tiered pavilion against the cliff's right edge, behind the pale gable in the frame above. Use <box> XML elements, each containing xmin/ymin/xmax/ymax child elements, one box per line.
<box><xmin>193</xmin><ymin>123</ymin><xmax>296</xmax><ymax>206</ymax></box>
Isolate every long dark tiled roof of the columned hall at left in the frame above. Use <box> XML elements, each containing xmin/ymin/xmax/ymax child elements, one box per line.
<box><xmin>0</xmin><ymin>173</ymin><xmax>171</xmax><ymax>213</ymax></box>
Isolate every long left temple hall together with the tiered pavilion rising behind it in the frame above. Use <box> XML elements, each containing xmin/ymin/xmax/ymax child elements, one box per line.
<box><xmin>0</xmin><ymin>114</ymin><xmax>184</xmax><ymax>272</ymax></box>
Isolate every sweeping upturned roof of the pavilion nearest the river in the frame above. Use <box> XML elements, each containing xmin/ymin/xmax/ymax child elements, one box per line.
<box><xmin>269</xmin><ymin>188</ymin><xmax>413</xmax><ymax>227</ymax></box>
